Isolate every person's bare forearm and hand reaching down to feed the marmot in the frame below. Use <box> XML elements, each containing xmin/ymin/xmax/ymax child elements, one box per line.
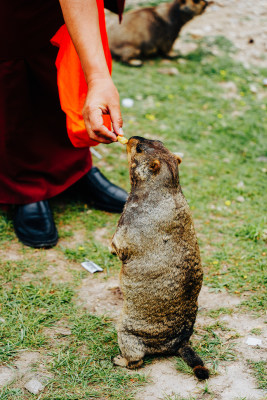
<box><xmin>59</xmin><ymin>0</ymin><xmax>122</xmax><ymax>143</ymax></box>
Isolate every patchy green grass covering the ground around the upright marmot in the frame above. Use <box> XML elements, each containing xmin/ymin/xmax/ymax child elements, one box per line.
<box><xmin>0</xmin><ymin>32</ymin><xmax>267</xmax><ymax>400</ymax></box>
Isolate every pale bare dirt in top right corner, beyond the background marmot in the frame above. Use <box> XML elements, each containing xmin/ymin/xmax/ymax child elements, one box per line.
<box><xmin>121</xmin><ymin>0</ymin><xmax>267</xmax><ymax>67</ymax></box>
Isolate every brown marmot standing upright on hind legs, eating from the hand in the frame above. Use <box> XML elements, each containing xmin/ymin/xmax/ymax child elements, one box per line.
<box><xmin>112</xmin><ymin>136</ymin><xmax>209</xmax><ymax>379</ymax></box>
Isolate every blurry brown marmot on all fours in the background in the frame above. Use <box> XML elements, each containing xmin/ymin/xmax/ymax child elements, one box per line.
<box><xmin>107</xmin><ymin>0</ymin><xmax>208</xmax><ymax>66</ymax></box>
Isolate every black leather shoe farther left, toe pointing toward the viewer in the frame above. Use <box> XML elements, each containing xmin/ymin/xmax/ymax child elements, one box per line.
<box><xmin>14</xmin><ymin>201</ymin><xmax>58</xmax><ymax>248</ymax></box>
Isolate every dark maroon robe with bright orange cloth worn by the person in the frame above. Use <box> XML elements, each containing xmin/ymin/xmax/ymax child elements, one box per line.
<box><xmin>0</xmin><ymin>0</ymin><xmax>124</xmax><ymax>204</ymax></box>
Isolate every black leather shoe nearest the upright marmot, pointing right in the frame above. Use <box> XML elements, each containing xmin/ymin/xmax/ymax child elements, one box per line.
<box><xmin>77</xmin><ymin>167</ymin><xmax>128</xmax><ymax>213</ymax></box>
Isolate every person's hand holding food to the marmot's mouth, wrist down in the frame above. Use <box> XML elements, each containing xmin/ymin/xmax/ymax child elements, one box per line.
<box><xmin>82</xmin><ymin>76</ymin><xmax>123</xmax><ymax>143</ymax></box>
